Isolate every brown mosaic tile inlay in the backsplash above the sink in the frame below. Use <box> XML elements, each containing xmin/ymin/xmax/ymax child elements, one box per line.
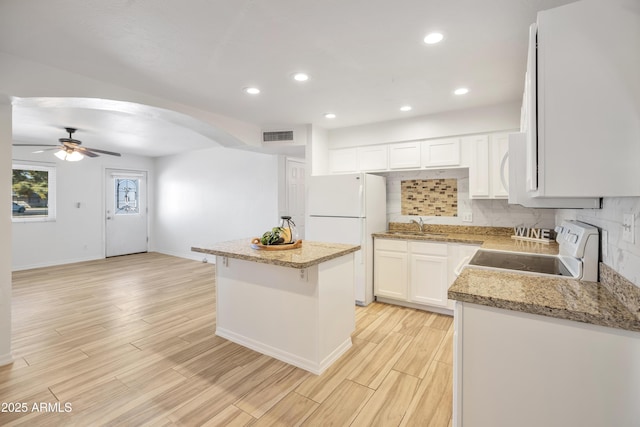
<box><xmin>401</xmin><ymin>179</ymin><xmax>458</xmax><ymax>216</ymax></box>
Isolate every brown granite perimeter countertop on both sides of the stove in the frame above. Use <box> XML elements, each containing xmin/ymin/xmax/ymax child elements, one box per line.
<box><xmin>373</xmin><ymin>224</ymin><xmax>640</xmax><ymax>332</ymax></box>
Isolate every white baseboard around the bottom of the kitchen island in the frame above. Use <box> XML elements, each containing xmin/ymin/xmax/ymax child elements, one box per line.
<box><xmin>216</xmin><ymin>327</ymin><xmax>351</xmax><ymax>375</ymax></box>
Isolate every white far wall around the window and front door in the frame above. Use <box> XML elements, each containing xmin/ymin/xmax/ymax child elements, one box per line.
<box><xmin>8</xmin><ymin>147</ymin><xmax>153</xmax><ymax>270</ymax></box>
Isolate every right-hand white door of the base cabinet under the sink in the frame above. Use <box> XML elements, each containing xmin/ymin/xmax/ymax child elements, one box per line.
<box><xmin>409</xmin><ymin>254</ymin><xmax>448</xmax><ymax>307</ymax></box>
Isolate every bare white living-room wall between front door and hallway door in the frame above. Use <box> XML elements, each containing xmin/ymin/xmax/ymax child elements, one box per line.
<box><xmin>153</xmin><ymin>148</ymin><xmax>279</xmax><ymax>261</ymax></box>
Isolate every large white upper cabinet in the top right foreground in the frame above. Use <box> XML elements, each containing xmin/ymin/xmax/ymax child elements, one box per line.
<box><xmin>510</xmin><ymin>0</ymin><xmax>640</xmax><ymax>198</ymax></box>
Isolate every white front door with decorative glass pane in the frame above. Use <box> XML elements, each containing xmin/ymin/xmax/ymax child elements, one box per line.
<box><xmin>105</xmin><ymin>169</ymin><xmax>148</xmax><ymax>257</ymax></box>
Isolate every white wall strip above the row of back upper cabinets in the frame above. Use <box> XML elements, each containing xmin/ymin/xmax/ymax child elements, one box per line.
<box><xmin>328</xmin><ymin>102</ymin><xmax>520</xmax><ymax>150</ymax></box>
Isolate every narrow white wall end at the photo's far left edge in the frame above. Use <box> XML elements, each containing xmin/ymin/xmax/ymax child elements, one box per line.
<box><xmin>0</xmin><ymin>99</ymin><xmax>13</xmax><ymax>366</ymax></box>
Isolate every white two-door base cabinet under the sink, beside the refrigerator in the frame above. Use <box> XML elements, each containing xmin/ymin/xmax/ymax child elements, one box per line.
<box><xmin>373</xmin><ymin>238</ymin><xmax>478</xmax><ymax>312</ymax></box>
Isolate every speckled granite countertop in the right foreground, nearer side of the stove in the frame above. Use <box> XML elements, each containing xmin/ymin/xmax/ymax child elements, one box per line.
<box><xmin>448</xmin><ymin>268</ymin><xmax>640</xmax><ymax>332</ymax></box>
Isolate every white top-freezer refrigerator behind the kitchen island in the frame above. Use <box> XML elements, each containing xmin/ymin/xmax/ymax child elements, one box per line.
<box><xmin>305</xmin><ymin>173</ymin><xmax>387</xmax><ymax>305</ymax></box>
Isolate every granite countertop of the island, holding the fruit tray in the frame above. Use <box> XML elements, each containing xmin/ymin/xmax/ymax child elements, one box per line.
<box><xmin>191</xmin><ymin>238</ymin><xmax>360</xmax><ymax>269</ymax></box>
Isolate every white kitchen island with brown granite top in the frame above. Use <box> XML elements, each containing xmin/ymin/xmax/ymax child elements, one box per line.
<box><xmin>191</xmin><ymin>238</ymin><xmax>360</xmax><ymax>374</ymax></box>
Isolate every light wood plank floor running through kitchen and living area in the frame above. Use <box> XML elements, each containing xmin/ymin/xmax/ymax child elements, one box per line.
<box><xmin>0</xmin><ymin>253</ymin><xmax>453</xmax><ymax>427</ymax></box>
